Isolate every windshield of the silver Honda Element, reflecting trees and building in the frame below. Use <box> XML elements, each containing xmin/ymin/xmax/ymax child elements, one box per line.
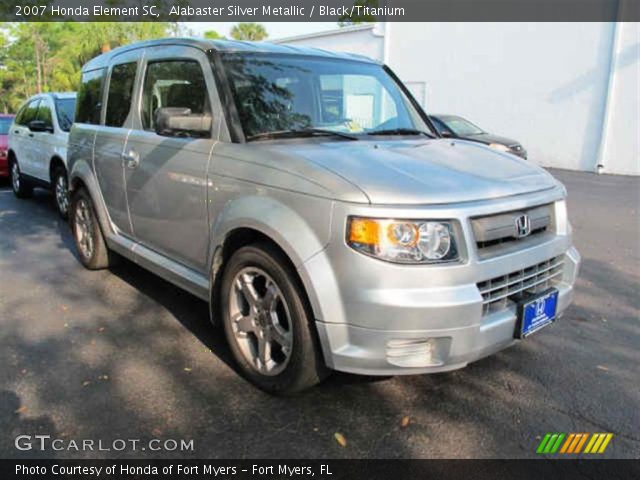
<box><xmin>223</xmin><ymin>54</ymin><xmax>429</xmax><ymax>140</ymax></box>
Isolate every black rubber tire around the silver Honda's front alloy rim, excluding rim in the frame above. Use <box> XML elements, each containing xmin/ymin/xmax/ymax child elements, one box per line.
<box><xmin>219</xmin><ymin>245</ymin><xmax>319</xmax><ymax>394</ymax></box>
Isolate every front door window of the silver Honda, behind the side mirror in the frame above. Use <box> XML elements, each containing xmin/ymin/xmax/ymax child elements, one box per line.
<box><xmin>141</xmin><ymin>60</ymin><xmax>211</xmax><ymax>130</ymax></box>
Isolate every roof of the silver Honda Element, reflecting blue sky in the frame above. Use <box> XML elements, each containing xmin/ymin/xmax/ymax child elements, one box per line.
<box><xmin>82</xmin><ymin>37</ymin><xmax>379</xmax><ymax>71</ymax></box>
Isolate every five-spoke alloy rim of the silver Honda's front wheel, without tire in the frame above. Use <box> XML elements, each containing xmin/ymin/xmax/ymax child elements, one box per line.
<box><xmin>229</xmin><ymin>267</ymin><xmax>293</xmax><ymax>376</ymax></box>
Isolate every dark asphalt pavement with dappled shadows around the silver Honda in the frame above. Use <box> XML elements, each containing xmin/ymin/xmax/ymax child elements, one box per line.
<box><xmin>0</xmin><ymin>171</ymin><xmax>640</xmax><ymax>458</ymax></box>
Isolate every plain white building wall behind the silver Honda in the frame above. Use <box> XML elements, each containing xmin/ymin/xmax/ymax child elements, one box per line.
<box><xmin>283</xmin><ymin>23</ymin><xmax>640</xmax><ymax>175</ymax></box>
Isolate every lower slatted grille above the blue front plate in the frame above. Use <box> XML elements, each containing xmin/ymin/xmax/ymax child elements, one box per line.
<box><xmin>477</xmin><ymin>256</ymin><xmax>564</xmax><ymax>315</ymax></box>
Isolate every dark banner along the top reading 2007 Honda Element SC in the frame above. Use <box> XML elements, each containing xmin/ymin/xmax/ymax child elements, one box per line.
<box><xmin>0</xmin><ymin>0</ymin><xmax>640</xmax><ymax>23</ymax></box>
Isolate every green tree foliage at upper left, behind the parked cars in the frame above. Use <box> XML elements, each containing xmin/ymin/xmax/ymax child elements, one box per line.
<box><xmin>0</xmin><ymin>22</ymin><xmax>179</xmax><ymax>112</ymax></box>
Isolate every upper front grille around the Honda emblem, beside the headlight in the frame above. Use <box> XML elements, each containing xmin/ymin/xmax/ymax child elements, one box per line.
<box><xmin>471</xmin><ymin>204</ymin><xmax>554</xmax><ymax>256</ymax></box>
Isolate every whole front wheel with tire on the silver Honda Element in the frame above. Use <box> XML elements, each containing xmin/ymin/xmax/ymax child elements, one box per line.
<box><xmin>219</xmin><ymin>244</ymin><xmax>328</xmax><ymax>395</ymax></box>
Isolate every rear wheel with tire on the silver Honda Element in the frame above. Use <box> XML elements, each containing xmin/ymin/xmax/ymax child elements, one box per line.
<box><xmin>69</xmin><ymin>188</ymin><xmax>111</xmax><ymax>270</ymax></box>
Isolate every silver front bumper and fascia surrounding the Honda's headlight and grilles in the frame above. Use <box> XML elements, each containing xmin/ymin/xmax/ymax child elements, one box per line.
<box><xmin>301</xmin><ymin>186</ymin><xmax>580</xmax><ymax>375</ymax></box>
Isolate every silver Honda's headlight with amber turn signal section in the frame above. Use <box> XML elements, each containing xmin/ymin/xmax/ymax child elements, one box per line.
<box><xmin>347</xmin><ymin>217</ymin><xmax>458</xmax><ymax>263</ymax></box>
